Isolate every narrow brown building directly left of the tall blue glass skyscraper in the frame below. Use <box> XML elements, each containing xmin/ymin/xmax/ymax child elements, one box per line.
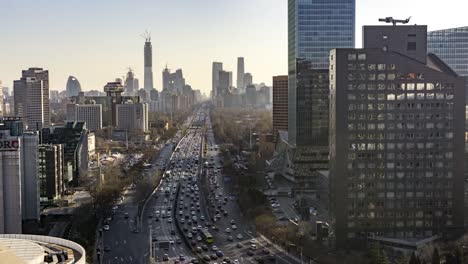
<box><xmin>273</xmin><ymin>75</ymin><xmax>288</xmax><ymax>142</ymax></box>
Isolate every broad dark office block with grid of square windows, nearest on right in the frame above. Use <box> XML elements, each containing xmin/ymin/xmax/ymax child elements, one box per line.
<box><xmin>330</xmin><ymin>26</ymin><xmax>465</xmax><ymax>247</ymax></box>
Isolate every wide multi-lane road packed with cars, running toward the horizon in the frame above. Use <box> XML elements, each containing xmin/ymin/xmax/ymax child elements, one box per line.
<box><xmin>102</xmin><ymin>108</ymin><xmax>300</xmax><ymax>264</ymax></box>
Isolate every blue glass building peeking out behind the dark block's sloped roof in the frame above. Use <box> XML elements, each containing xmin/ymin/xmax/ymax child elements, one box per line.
<box><xmin>427</xmin><ymin>27</ymin><xmax>468</xmax><ymax>104</ymax></box>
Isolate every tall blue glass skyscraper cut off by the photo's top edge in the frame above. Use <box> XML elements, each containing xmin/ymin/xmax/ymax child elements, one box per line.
<box><xmin>288</xmin><ymin>0</ymin><xmax>356</xmax><ymax>193</ymax></box>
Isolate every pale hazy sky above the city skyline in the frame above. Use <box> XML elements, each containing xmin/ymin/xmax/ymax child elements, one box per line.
<box><xmin>0</xmin><ymin>0</ymin><xmax>468</xmax><ymax>95</ymax></box>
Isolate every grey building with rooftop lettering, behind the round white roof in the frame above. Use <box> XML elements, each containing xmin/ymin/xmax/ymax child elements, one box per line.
<box><xmin>0</xmin><ymin>118</ymin><xmax>39</xmax><ymax>234</ymax></box>
